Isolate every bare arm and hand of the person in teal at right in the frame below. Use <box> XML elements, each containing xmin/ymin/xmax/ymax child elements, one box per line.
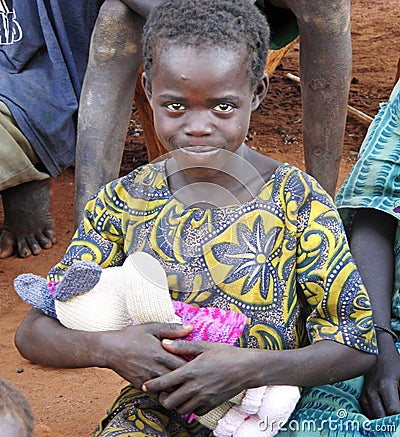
<box><xmin>350</xmin><ymin>209</ymin><xmax>400</xmax><ymax>418</ymax></box>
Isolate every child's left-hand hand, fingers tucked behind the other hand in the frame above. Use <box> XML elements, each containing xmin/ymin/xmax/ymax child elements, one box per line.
<box><xmin>99</xmin><ymin>323</ymin><xmax>193</xmax><ymax>389</ymax></box>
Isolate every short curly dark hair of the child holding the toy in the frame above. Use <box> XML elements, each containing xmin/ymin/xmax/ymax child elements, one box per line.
<box><xmin>143</xmin><ymin>0</ymin><xmax>269</xmax><ymax>87</ymax></box>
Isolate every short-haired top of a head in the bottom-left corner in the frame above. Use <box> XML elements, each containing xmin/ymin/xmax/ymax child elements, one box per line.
<box><xmin>0</xmin><ymin>378</ymin><xmax>35</xmax><ymax>437</ymax></box>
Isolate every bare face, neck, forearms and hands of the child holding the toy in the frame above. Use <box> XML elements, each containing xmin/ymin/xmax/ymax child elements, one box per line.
<box><xmin>15</xmin><ymin>46</ymin><xmax>375</xmax><ymax>414</ymax></box>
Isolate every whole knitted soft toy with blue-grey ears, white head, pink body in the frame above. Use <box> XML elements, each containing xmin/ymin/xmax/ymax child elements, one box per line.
<box><xmin>14</xmin><ymin>252</ymin><xmax>300</xmax><ymax>437</ymax></box>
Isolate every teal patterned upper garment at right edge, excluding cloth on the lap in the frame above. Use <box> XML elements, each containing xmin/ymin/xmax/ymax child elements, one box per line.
<box><xmin>335</xmin><ymin>80</ymin><xmax>400</xmax><ymax>334</ymax></box>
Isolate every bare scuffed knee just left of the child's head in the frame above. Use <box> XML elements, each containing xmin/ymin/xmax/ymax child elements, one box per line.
<box><xmin>90</xmin><ymin>0</ymin><xmax>145</xmax><ymax>65</ymax></box>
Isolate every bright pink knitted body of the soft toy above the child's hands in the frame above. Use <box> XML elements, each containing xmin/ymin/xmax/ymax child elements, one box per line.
<box><xmin>173</xmin><ymin>301</ymin><xmax>247</xmax><ymax>345</ymax></box>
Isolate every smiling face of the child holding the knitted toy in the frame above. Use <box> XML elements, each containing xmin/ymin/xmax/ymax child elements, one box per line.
<box><xmin>144</xmin><ymin>46</ymin><xmax>267</xmax><ymax>174</ymax></box>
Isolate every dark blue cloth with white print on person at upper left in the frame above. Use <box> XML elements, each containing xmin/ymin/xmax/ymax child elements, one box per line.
<box><xmin>0</xmin><ymin>0</ymin><xmax>104</xmax><ymax>177</ymax></box>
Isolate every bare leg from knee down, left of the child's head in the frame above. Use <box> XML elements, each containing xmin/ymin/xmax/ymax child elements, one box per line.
<box><xmin>75</xmin><ymin>0</ymin><xmax>144</xmax><ymax>226</ymax></box>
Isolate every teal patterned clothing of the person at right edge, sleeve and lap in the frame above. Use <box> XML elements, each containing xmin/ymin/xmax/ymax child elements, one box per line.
<box><xmin>279</xmin><ymin>81</ymin><xmax>400</xmax><ymax>437</ymax></box>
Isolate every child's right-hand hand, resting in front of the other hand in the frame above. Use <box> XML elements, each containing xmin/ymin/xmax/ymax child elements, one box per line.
<box><xmin>142</xmin><ymin>340</ymin><xmax>252</xmax><ymax>415</ymax></box>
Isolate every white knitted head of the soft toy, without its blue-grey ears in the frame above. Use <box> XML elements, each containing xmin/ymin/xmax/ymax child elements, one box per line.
<box><xmin>54</xmin><ymin>252</ymin><xmax>181</xmax><ymax>331</ymax></box>
